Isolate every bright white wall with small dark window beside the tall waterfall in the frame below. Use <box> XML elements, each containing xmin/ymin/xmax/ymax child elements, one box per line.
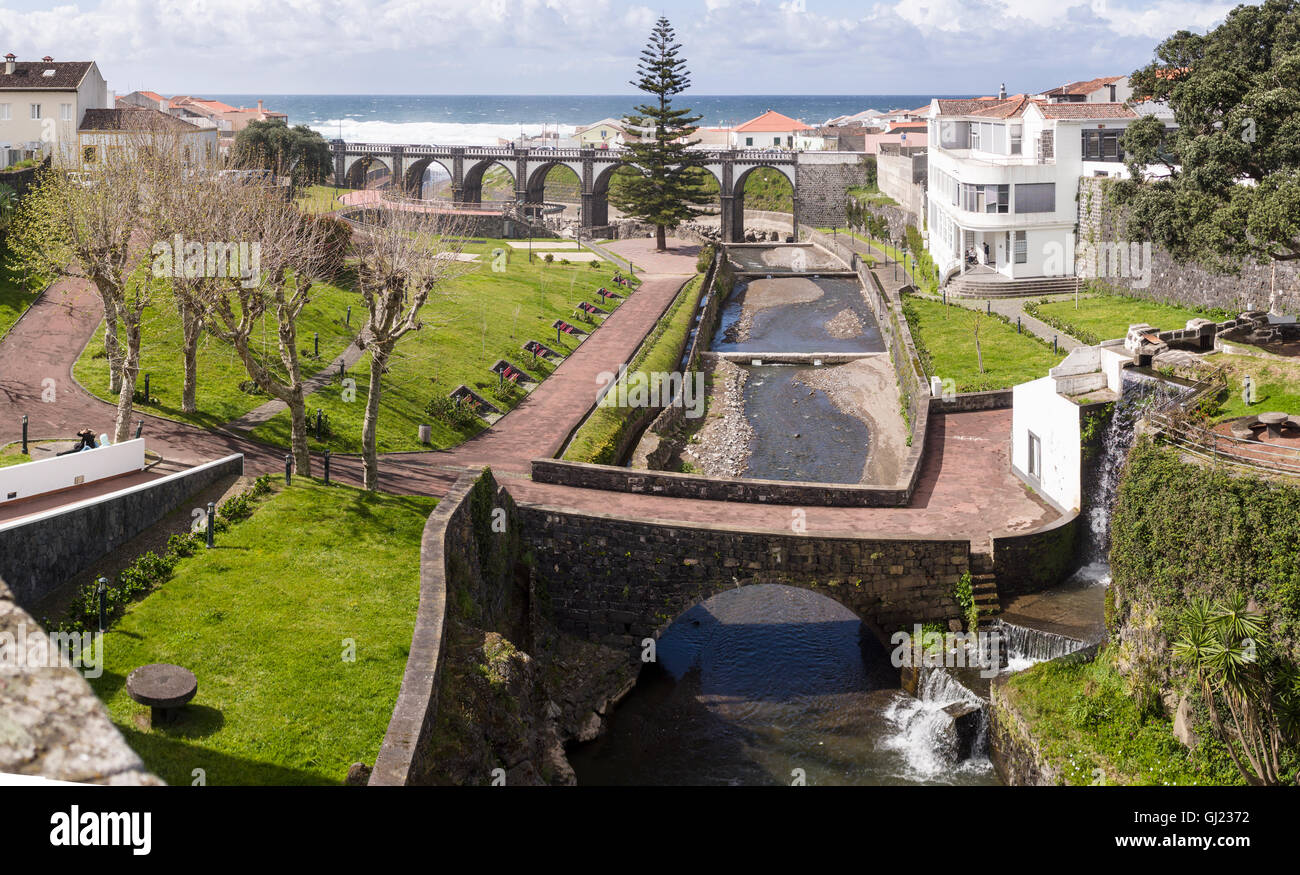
<box><xmin>1011</xmin><ymin>377</ymin><xmax>1083</xmax><ymax>511</ymax></box>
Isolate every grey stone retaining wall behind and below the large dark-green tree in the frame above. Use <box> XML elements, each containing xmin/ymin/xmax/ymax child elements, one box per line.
<box><xmin>1078</xmin><ymin>178</ymin><xmax>1300</xmax><ymax>315</ymax></box>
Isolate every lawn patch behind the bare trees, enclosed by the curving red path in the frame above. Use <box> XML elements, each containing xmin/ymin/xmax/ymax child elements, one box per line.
<box><xmin>73</xmin><ymin>283</ymin><xmax>365</xmax><ymax>428</ymax></box>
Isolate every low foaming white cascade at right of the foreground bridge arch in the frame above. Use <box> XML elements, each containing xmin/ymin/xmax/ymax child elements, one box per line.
<box><xmin>880</xmin><ymin>668</ymin><xmax>992</xmax><ymax>780</ymax></box>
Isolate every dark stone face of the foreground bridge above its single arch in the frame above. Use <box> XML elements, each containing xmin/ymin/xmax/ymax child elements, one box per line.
<box><xmin>519</xmin><ymin>504</ymin><xmax>970</xmax><ymax>649</ymax></box>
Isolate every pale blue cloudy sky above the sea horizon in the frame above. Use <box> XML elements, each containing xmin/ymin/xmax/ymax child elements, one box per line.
<box><xmin>0</xmin><ymin>0</ymin><xmax>1236</xmax><ymax>95</ymax></box>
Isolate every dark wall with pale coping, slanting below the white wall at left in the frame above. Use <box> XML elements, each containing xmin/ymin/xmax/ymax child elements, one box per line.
<box><xmin>0</xmin><ymin>454</ymin><xmax>243</xmax><ymax>607</ymax></box>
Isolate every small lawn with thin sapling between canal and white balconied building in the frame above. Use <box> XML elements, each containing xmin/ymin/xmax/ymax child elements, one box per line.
<box><xmin>904</xmin><ymin>295</ymin><xmax>1065</xmax><ymax>391</ymax></box>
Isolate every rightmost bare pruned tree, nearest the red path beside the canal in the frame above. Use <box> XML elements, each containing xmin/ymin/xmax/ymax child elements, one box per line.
<box><xmin>352</xmin><ymin>209</ymin><xmax>467</xmax><ymax>489</ymax></box>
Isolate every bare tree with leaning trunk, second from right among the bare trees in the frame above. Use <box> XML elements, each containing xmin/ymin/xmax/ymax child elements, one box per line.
<box><xmin>204</xmin><ymin>177</ymin><xmax>329</xmax><ymax>476</ymax></box>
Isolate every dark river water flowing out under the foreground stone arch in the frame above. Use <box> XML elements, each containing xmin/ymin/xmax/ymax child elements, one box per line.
<box><xmin>569</xmin><ymin>584</ymin><xmax>997</xmax><ymax>785</ymax></box>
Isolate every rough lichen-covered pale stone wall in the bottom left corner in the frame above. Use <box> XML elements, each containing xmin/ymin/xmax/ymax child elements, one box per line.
<box><xmin>0</xmin><ymin>580</ymin><xmax>163</xmax><ymax>787</ymax></box>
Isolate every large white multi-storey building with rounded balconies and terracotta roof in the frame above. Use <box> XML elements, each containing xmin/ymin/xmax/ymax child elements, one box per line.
<box><xmin>927</xmin><ymin>95</ymin><xmax>1138</xmax><ymax>294</ymax></box>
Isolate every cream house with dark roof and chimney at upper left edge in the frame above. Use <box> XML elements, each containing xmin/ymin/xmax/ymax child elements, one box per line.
<box><xmin>0</xmin><ymin>53</ymin><xmax>112</xmax><ymax>166</ymax></box>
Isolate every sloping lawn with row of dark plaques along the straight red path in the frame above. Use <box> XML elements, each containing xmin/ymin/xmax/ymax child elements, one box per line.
<box><xmin>252</xmin><ymin>241</ymin><xmax>625</xmax><ymax>452</ymax></box>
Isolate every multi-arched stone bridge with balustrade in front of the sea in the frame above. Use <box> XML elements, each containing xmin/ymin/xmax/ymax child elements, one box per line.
<box><xmin>332</xmin><ymin>140</ymin><xmax>866</xmax><ymax>242</ymax></box>
